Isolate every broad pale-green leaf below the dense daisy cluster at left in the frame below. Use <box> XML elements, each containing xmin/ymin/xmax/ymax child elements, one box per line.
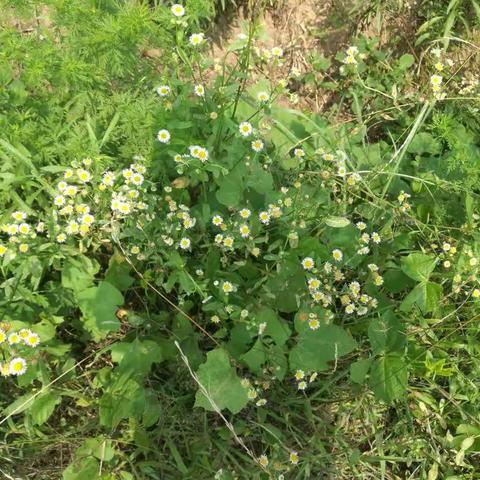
<box><xmin>77</xmin><ymin>282</ymin><xmax>123</xmax><ymax>339</ymax></box>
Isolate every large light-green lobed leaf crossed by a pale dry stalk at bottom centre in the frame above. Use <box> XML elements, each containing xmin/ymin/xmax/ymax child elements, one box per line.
<box><xmin>195</xmin><ymin>348</ymin><xmax>248</xmax><ymax>413</ymax></box>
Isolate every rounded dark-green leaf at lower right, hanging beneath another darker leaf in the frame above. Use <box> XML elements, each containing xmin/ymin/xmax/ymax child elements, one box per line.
<box><xmin>370</xmin><ymin>354</ymin><xmax>408</xmax><ymax>402</ymax></box>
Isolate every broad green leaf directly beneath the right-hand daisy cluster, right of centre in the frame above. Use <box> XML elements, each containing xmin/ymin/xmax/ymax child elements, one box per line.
<box><xmin>290</xmin><ymin>325</ymin><xmax>357</xmax><ymax>372</ymax></box>
